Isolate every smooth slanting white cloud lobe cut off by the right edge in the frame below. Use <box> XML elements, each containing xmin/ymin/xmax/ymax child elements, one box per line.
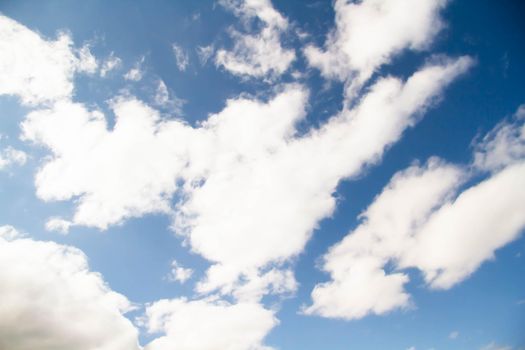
<box><xmin>400</xmin><ymin>162</ymin><xmax>525</xmax><ymax>289</ymax></box>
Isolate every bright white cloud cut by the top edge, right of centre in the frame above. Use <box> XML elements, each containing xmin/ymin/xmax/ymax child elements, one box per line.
<box><xmin>304</xmin><ymin>0</ymin><xmax>447</xmax><ymax>98</ymax></box>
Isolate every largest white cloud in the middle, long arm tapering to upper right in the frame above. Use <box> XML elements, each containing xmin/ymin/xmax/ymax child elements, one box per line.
<box><xmin>22</xmin><ymin>57</ymin><xmax>471</xmax><ymax>296</ymax></box>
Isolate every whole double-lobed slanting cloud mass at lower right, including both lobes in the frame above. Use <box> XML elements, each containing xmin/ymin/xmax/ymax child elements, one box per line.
<box><xmin>304</xmin><ymin>113</ymin><xmax>525</xmax><ymax>319</ymax></box>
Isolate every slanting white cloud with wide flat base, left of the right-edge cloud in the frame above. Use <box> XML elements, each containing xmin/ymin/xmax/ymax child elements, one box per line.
<box><xmin>304</xmin><ymin>159</ymin><xmax>462</xmax><ymax>319</ymax></box>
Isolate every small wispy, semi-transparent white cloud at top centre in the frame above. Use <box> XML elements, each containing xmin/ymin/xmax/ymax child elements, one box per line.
<box><xmin>215</xmin><ymin>0</ymin><xmax>295</xmax><ymax>78</ymax></box>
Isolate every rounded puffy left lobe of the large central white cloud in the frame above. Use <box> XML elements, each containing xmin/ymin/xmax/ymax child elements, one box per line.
<box><xmin>21</xmin><ymin>99</ymin><xmax>191</xmax><ymax>229</ymax></box>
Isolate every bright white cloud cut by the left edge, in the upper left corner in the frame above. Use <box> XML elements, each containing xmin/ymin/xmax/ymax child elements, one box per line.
<box><xmin>0</xmin><ymin>15</ymin><xmax>97</xmax><ymax>105</ymax></box>
